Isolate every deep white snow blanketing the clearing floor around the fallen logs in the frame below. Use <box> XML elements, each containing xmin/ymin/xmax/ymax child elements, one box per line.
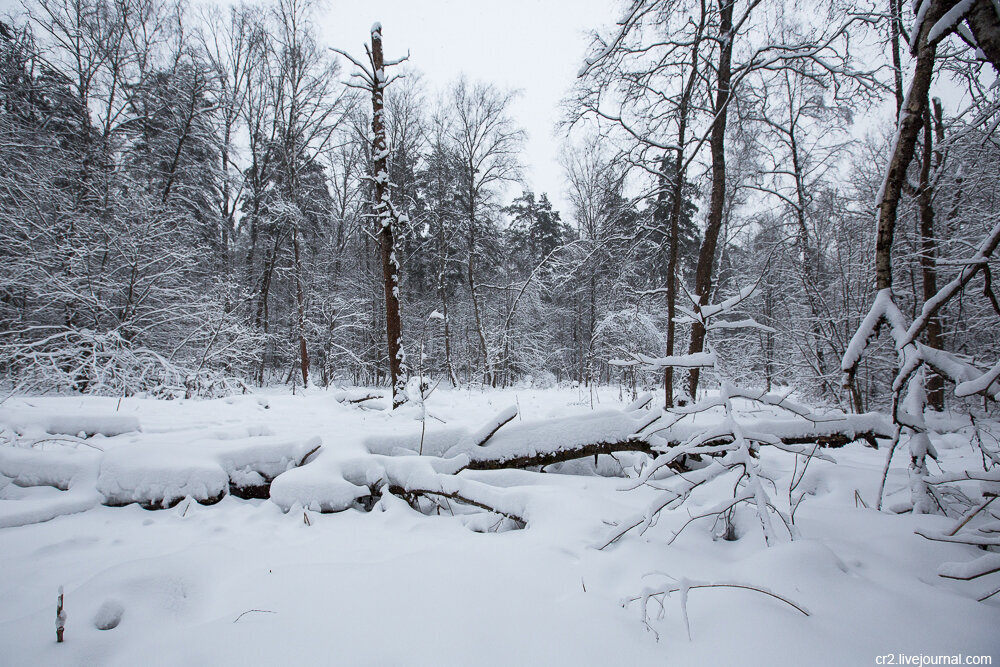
<box><xmin>0</xmin><ymin>388</ymin><xmax>1000</xmax><ymax>665</ymax></box>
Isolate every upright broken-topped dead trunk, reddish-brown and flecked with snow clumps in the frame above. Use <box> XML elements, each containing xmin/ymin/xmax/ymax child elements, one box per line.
<box><xmin>371</xmin><ymin>26</ymin><xmax>406</xmax><ymax>409</ymax></box>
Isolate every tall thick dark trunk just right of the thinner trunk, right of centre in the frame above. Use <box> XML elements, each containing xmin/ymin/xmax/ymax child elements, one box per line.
<box><xmin>688</xmin><ymin>0</ymin><xmax>735</xmax><ymax>398</ymax></box>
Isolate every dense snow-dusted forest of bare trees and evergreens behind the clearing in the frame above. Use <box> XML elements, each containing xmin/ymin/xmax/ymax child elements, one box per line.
<box><xmin>0</xmin><ymin>0</ymin><xmax>1000</xmax><ymax>411</ymax></box>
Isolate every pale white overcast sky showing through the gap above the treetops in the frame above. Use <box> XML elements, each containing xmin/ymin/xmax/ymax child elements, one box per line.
<box><xmin>320</xmin><ymin>0</ymin><xmax>620</xmax><ymax>221</ymax></box>
